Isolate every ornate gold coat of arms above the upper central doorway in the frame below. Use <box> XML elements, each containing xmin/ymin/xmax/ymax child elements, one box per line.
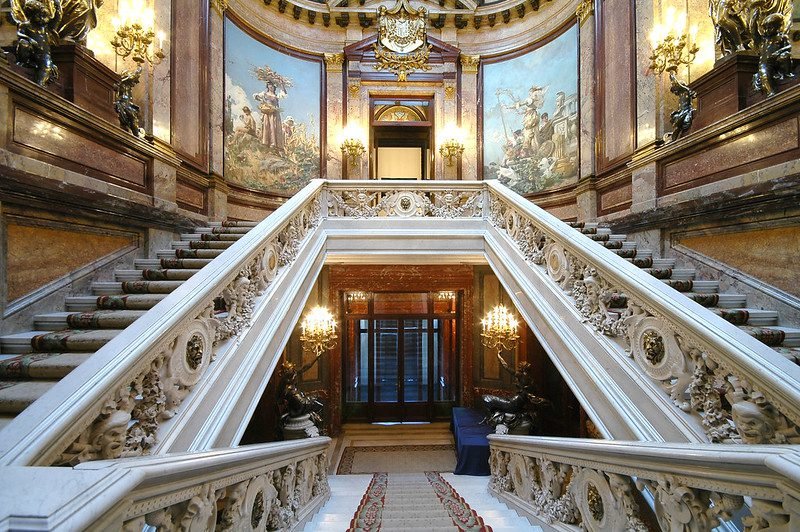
<box><xmin>374</xmin><ymin>0</ymin><xmax>432</xmax><ymax>81</ymax></box>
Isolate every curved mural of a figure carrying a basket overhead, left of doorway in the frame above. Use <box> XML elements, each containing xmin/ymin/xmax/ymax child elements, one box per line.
<box><xmin>225</xmin><ymin>19</ymin><xmax>322</xmax><ymax>196</ymax></box>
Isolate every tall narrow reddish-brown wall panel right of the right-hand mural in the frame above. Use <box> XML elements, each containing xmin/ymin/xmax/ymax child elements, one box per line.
<box><xmin>597</xmin><ymin>0</ymin><xmax>636</xmax><ymax>173</ymax></box>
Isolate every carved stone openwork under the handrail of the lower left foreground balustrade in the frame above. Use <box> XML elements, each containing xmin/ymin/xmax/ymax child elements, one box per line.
<box><xmin>123</xmin><ymin>452</ymin><xmax>330</xmax><ymax>532</ymax></box>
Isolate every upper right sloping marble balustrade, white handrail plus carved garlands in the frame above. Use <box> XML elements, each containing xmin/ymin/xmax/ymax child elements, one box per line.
<box><xmin>486</xmin><ymin>181</ymin><xmax>800</xmax><ymax>444</ymax></box>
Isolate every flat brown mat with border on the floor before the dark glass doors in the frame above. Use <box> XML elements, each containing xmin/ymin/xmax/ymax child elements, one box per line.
<box><xmin>336</xmin><ymin>444</ymin><xmax>456</xmax><ymax>475</ymax></box>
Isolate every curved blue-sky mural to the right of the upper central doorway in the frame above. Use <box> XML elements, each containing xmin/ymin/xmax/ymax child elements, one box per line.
<box><xmin>483</xmin><ymin>26</ymin><xmax>579</xmax><ymax>194</ymax></box>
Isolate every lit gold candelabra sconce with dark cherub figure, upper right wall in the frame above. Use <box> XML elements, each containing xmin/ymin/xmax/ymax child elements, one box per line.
<box><xmin>650</xmin><ymin>8</ymin><xmax>700</xmax><ymax>141</ymax></box>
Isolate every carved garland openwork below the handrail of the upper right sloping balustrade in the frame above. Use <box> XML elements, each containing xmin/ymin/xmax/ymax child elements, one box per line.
<box><xmin>489</xmin><ymin>195</ymin><xmax>800</xmax><ymax>444</ymax></box>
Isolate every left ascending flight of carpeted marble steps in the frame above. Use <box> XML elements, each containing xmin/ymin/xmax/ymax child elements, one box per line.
<box><xmin>0</xmin><ymin>222</ymin><xmax>256</xmax><ymax>429</ymax></box>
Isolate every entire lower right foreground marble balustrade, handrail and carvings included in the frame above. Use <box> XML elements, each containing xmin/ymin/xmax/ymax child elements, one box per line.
<box><xmin>489</xmin><ymin>435</ymin><xmax>800</xmax><ymax>532</ymax></box>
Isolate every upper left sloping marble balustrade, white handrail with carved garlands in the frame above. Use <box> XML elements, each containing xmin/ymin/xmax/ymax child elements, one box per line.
<box><xmin>0</xmin><ymin>180</ymin><xmax>323</xmax><ymax>465</ymax></box>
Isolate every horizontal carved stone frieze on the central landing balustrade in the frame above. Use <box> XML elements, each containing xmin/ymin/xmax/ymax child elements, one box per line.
<box><xmin>328</xmin><ymin>188</ymin><xmax>483</xmax><ymax>218</ymax></box>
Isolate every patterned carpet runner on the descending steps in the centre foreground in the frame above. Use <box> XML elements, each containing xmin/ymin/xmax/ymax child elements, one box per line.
<box><xmin>348</xmin><ymin>472</ymin><xmax>492</xmax><ymax>532</ymax></box>
